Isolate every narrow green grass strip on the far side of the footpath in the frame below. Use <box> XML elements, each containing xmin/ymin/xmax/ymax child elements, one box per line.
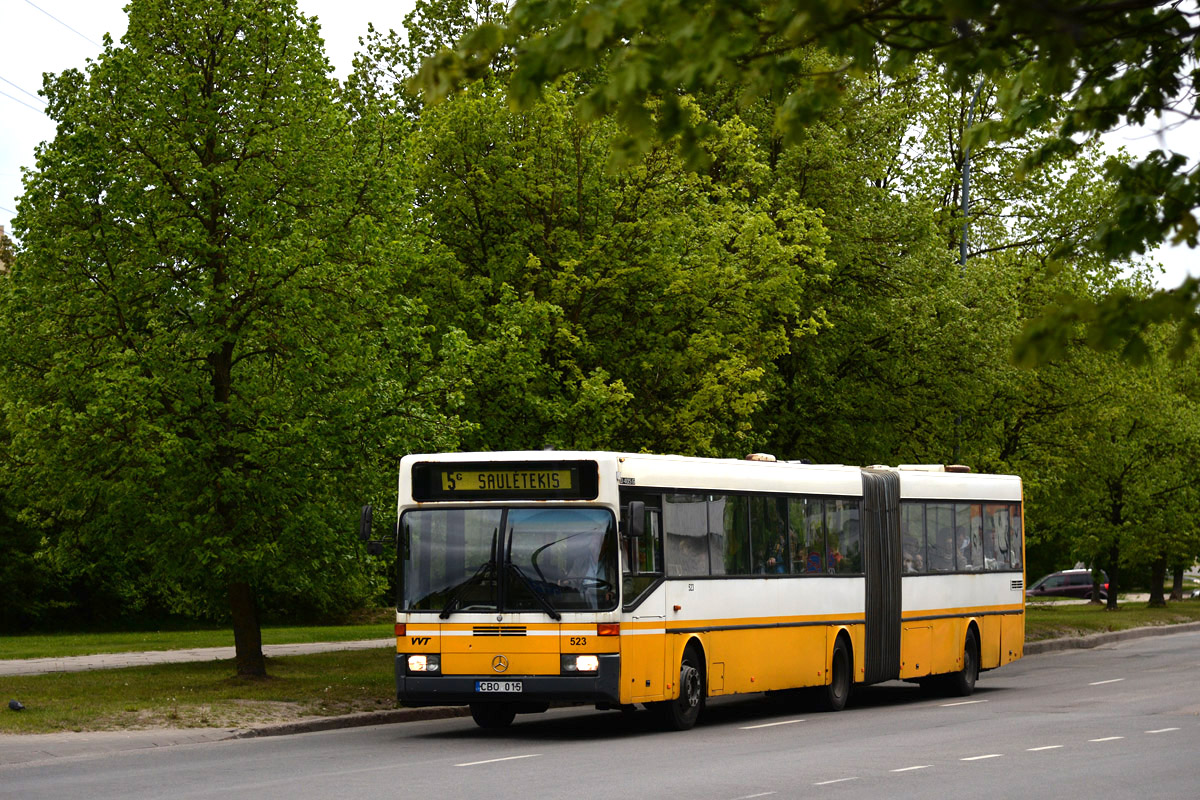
<box><xmin>0</xmin><ymin>613</ymin><xmax>395</xmax><ymax>658</ymax></box>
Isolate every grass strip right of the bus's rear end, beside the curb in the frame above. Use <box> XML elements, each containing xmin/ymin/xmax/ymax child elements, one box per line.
<box><xmin>1025</xmin><ymin>600</ymin><xmax>1200</xmax><ymax>642</ymax></box>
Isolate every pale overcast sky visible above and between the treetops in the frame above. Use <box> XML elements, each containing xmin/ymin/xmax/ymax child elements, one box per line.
<box><xmin>0</xmin><ymin>0</ymin><xmax>1200</xmax><ymax>287</ymax></box>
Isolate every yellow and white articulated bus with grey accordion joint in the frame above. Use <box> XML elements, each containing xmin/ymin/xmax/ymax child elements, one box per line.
<box><xmin>396</xmin><ymin>451</ymin><xmax>1025</xmax><ymax>730</ymax></box>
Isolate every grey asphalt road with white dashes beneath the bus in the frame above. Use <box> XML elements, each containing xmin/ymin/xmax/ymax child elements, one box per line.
<box><xmin>0</xmin><ymin>632</ymin><xmax>1200</xmax><ymax>800</ymax></box>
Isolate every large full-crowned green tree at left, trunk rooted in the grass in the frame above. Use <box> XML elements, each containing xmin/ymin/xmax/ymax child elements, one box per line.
<box><xmin>0</xmin><ymin>0</ymin><xmax>458</xmax><ymax>675</ymax></box>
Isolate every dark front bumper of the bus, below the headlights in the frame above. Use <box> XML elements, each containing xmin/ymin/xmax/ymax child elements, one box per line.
<box><xmin>396</xmin><ymin>654</ymin><xmax>620</xmax><ymax>705</ymax></box>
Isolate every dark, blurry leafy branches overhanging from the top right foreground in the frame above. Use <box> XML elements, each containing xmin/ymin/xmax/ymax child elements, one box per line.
<box><xmin>418</xmin><ymin>0</ymin><xmax>1200</xmax><ymax>353</ymax></box>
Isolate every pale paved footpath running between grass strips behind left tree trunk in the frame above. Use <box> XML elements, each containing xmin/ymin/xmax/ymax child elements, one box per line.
<box><xmin>0</xmin><ymin>637</ymin><xmax>396</xmax><ymax>678</ymax></box>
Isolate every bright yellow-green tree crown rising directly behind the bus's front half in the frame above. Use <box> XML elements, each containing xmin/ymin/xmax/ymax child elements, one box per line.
<box><xmin>413</xmin><ymin>82</ymin><xmax>828</xmax><ymax>455</ymax></box>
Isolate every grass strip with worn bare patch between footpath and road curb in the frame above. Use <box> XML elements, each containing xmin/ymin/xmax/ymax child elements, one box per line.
<box><xmin>0</xmin><ymin>648</ymin><xmax>396</xmax><ymax>734</ymax></box>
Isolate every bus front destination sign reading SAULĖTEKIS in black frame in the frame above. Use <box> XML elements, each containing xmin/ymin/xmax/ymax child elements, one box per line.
<box><xmin>413</xmin><ymin>461</ymin><xmax>599</xmax><ymax>500</ymax></box>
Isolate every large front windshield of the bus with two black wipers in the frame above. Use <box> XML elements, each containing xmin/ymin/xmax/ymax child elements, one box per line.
<box><xmin>401</xmin><ymin>506</ymin><xmax>618</xmax><ymax>618</ymax></box>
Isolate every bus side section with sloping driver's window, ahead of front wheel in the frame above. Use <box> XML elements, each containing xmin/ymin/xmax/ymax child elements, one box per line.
<box><xmin>620</xmin><ymin>506</ymin><xmax>667</xmax><ymax>703</ymax></box>
